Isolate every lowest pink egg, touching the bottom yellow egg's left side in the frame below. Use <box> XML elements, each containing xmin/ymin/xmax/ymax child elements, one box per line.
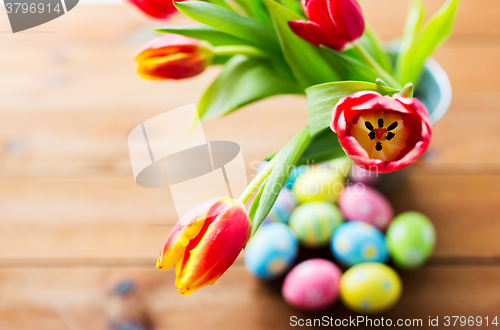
<box><xmin>282</xmin><ymin>259</ymin><xmax>342</xmax><ymax>312</ymax></box>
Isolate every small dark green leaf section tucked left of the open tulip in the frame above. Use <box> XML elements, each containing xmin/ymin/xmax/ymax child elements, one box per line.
<box><xmin>296</xmin><ymin>129</ymin><xmax>345</xmax><ymax>166</ymax></box>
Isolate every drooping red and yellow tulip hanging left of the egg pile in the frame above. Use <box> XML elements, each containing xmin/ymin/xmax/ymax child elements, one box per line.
<box><xmin>156</xmin><ymin>198</ymin><xmax>250</xmax><ymax>296</ymax></box>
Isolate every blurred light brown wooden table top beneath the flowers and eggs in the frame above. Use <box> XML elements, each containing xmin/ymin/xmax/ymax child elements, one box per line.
<box><xmin>0</xmin><ymin>0</ymin><xmax>500</xmax><ymax>330</ymax></box>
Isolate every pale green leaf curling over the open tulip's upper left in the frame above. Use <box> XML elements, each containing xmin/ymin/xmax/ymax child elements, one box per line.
<box><xmin>306</xmin><ymin>81</ymin><xmax>398</xmax><ymax>137</ymax></box>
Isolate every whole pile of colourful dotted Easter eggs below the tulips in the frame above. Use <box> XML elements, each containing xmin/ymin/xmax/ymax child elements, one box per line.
<box><xmin>245</xmin><ymin>160</ymin><xmax>435</xmax><ymax>313</ymax></box>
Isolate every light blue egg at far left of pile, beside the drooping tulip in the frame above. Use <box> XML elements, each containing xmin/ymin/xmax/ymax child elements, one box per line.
<box><xmin>245</xmin><ymin>223</ymin><xmax>299</xmax><ymax>280</ymax></box>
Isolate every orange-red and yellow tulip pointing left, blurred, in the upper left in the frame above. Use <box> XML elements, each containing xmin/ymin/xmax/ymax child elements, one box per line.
<box><xmin>135</xmin><ymin>34</ymin><xmax>213</xmax><ymax>79</ymax></box>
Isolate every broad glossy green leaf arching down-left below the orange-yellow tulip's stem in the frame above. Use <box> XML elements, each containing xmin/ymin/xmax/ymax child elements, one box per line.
<box><xmin>198</xmin><ymin>55</ymin><xmax>302</xmax><ymax>121</ymax></box>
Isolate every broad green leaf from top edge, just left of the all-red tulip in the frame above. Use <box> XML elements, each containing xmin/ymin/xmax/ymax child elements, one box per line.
<box><xmin>264</xmin><ymin>0</ymin><xmax>340</xmax><ymax>89</ymax></box>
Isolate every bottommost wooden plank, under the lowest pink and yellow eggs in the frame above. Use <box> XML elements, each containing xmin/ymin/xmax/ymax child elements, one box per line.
<box><xmin>0</xmin><ymin>266</ymin><xmax>500</xmax><ymax>330</ymax></box>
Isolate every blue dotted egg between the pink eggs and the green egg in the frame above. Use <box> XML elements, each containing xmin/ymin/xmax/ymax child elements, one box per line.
<box><xmin>331</xmin><ymin>221</ymin><xmax>389</xmax><ymax>266</ymax></box>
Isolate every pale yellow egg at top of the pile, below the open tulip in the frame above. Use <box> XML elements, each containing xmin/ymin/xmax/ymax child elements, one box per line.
<box><xmin>292</xmin><ymin>166</ymin><xmax>344</xmax><ymax>203</ymax></box>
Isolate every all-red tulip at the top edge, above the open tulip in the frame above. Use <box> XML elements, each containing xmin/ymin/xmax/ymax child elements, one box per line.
<box><xmin>288</xmin><ymin>0</ymin><xmax>365</xmax><ymax>51</ymax></box>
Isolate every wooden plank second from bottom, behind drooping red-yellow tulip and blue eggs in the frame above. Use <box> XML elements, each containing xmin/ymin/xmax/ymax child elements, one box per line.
<box><xmin>0</xmin><ymin>171</ymin><xmax>500</xmax><ymax>262</ymax></box>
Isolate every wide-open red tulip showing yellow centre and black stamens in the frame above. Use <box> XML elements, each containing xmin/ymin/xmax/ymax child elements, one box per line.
<box><xmin>330</xmin><ymin>91</ymin><xmax>431</xmax><ymax>173</ymax></box>
